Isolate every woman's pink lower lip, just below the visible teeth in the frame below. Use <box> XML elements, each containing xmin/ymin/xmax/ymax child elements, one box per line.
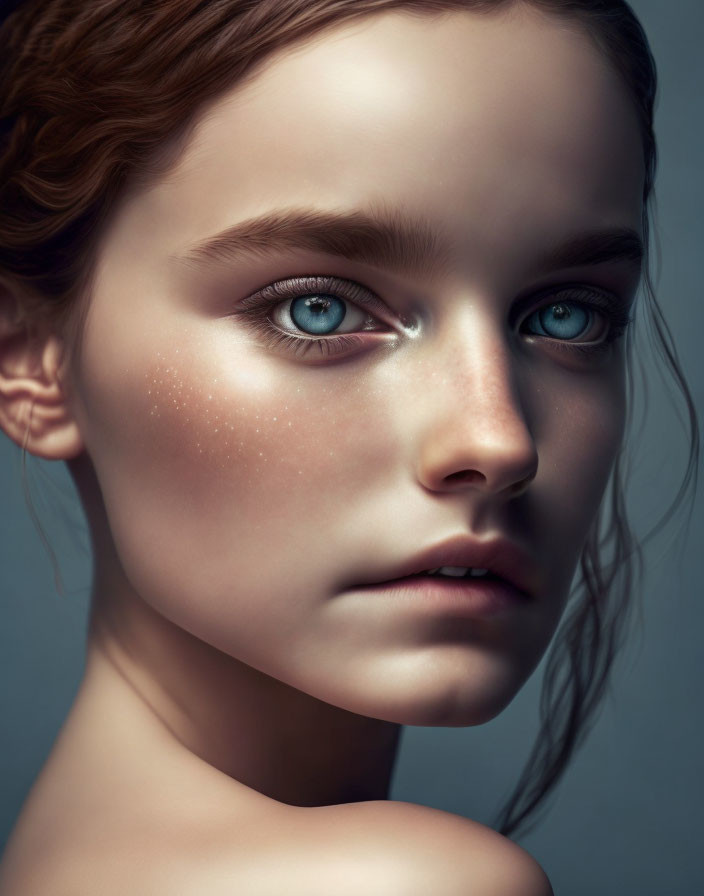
<box><xmin>360</xmin><ymin>576</ymin><xmax>530</xmax><ymax>617</ymax></box>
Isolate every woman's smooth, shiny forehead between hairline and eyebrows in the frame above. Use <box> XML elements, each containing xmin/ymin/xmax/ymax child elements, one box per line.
<box><xmin>111</xmin><ymin>4</ymin><xmax>643</xmax><ymax>280</ymax></box>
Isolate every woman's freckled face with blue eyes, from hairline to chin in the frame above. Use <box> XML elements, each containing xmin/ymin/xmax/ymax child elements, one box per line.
<box><xmin>66</xmin><ymin>8</ymin><xmax>643</xmax><ymax>725</ymax></box>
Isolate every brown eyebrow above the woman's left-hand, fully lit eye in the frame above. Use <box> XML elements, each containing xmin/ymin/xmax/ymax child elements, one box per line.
<box><xmin>178</xmin><ymin>210</ymin><xmax>444</xmax><ymax>274</ymax></box>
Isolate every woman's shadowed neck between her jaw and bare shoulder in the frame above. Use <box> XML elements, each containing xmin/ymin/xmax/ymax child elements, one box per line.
<box><xmin>89</xmin><ymin>577</ymin><xmax>400</xmax><ymax>806</ymax></box>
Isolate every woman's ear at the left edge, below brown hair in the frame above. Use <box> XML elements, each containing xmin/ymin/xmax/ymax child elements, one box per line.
<box><xmin>0</xmin><ymin>284</ymin><xmax>83</xmax><ymax>460</ymax></box>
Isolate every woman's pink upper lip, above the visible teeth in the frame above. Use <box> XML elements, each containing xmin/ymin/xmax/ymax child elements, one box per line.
<box><xmin>358</xmin><ymin>536</ymin><xmax>539</xmax><ymax>597</ymax></box>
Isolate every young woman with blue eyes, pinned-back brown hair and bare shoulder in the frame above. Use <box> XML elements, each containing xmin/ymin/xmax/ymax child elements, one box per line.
<box><xmin>0</xmin><ymin>0</ymin><xmax>697</xmax><ymax>896</ymax></box>
